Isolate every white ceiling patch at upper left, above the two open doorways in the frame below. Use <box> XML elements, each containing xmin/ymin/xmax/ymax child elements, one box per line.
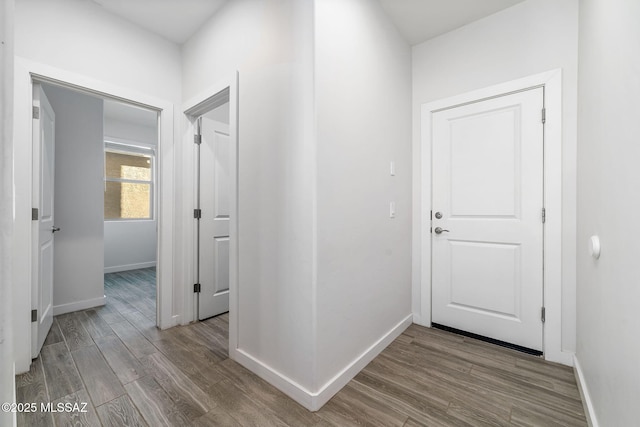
<box><xmin>91</xmin><ymin>0</ymin><xmax>227</xmax><ymax>44</ymax></box>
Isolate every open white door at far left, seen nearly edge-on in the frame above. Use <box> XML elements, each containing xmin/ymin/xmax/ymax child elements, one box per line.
<box><xmin>31</xmin><ymin>84</ymin><xmax>57</xmax><ymax>358</ymax></box>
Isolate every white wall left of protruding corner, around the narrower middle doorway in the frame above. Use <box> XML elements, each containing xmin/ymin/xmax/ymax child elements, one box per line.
<box><xmin>182</xmin><ymin>0</ymin><xmax>315</xmax><ymax>390</ymax></box>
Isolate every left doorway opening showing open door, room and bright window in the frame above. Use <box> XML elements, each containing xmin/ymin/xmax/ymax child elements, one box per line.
<box><xmin>32</xmin><ymin>82</ymin><xmax>158</xmax><ymax>358</ymax></box>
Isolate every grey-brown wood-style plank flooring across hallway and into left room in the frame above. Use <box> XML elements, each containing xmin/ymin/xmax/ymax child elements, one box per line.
<box><xmin>16</xmin><ymin>269</ymin><xmax>587</xmax><ymax>427</ymax></box>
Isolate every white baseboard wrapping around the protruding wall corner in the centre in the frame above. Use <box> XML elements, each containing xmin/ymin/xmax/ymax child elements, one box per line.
<box><xmin>230</xmin><ymin>314</ymin><xmax>413</xmax><ymax>411</ymax></box>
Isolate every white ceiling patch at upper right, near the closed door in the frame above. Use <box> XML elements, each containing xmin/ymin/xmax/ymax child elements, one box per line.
<box><xmin>380</xmin><ymin>0</ymin><xmax>524</xmax><ymax>45</ymax></box>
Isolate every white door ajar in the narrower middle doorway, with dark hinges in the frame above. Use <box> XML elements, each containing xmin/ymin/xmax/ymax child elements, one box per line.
<box><xmin>198</xmin><ymin>116</ymin><xmax>232</xmax><ymax>320</ymax></box>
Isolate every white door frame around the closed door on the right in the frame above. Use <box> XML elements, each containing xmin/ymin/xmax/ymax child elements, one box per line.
<box><xmin>412</xmin><ymin>69</ymin><xmax>573</xmax><ymax>365</ymax></box>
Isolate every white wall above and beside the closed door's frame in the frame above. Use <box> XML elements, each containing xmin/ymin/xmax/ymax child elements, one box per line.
<box><xmin>412</xmin><ymin>0</ymin><xmax>578</xmax><ymax>352</ymax></box>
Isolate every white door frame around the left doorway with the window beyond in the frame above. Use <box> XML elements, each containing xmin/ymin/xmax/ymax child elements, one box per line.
<box><xmin>12</xmin><ymin>57</ymin><xmax>179</xmax><ymax>373</ymax></box>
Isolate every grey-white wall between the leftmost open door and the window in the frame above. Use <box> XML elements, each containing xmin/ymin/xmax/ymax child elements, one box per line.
<box><xmin>43</xmin><ymin>85</ymin><xmax>104</xmax><ymax>314</ymax></box>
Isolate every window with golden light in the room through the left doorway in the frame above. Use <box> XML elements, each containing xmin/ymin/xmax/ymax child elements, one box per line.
<box><xmin>104</xmin><ymin>142</ymin><xmax>154</xmax><ymax>220</ymax></box>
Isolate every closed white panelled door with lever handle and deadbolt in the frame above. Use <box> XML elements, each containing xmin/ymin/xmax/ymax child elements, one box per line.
<box><xmin>431</xmin><ymin>88</ymin><xmax>543</xmax><ymax>351</ymax></box>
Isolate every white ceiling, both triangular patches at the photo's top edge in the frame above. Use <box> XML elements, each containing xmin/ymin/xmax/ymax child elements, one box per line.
<box><xmin>90</xmin><ymin>0</ymin><xmax>524</xmax><ymax>45</ymax></box>
